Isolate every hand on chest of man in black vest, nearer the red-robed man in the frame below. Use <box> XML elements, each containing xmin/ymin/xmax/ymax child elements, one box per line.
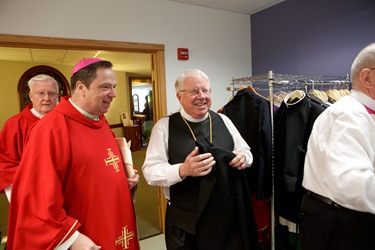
<box><xmin>179</xmin><ymin>147</ymin><xmax>216</xmax><ymax>178</ymax></box>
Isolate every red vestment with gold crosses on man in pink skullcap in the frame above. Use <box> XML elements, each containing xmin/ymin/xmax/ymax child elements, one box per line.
<box><xmin>7</xmin><ymin>98</ymin><xmax>139</xmax><ymax>250</ymax></box>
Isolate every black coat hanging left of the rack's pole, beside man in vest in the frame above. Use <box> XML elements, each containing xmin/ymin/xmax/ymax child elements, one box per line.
<box><xmin>222</xmin><ymin>88</ymin><xmax>272</xmax><ymax>199</ymax></box>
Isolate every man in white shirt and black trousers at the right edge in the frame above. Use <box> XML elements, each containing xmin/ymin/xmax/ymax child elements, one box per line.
<box><xmin>300</xmin><ymin>43</ymin><xmax>375</xmax><ymax>250</ymax></box>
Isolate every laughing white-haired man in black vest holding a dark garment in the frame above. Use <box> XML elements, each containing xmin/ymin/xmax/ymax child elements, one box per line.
<box><xmin>142</xmin><ymin>69</ymin><xmax>258</xmax><ymax>250</ymax></box>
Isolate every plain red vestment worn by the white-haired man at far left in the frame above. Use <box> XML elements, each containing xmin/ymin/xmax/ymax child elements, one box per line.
<box><xmin>0</xmin><ymin>104</ymin><xmax>39</xmax><ymax>190</ymax></box>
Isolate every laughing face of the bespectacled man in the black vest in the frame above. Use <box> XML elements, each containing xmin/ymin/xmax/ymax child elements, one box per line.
<box><xmin>176</xmin><ymin>75</ymin><xmax>212</xmax><ymax>119</ymax></box>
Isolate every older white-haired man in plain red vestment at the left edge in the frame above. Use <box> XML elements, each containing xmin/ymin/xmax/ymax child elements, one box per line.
<box><xmin>0</xmin><ymin>74</ymin><xmax>59</xmax><ymax>200</ymax></box>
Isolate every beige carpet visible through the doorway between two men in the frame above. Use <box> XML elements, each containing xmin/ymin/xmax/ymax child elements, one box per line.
<box><xmin>132</xmin><ymin>147</ymin><xmax>162</xmax><ymax>240</ymax></box>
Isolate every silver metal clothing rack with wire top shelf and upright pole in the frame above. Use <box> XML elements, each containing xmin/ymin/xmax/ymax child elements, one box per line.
<box><xmin>227</xmin><ymin>70</ymin><xmax>351</xmax><ymax>250</ymax></box>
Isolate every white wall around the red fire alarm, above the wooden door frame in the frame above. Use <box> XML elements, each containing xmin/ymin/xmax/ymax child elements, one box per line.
<box><xmin>0</xmin><ymin>0</ymin><xmax>251</xmax><ymax>112</ymax></box>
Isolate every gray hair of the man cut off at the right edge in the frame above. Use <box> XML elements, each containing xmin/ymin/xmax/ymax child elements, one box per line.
<box><xmin>350</xmin><ymin>43</ymin><xmax>375</xmax><ymax>85</ymax></box>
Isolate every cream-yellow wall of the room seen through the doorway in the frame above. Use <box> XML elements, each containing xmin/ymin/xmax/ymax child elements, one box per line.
<box><xmin>0</xmin><ymin>61</ymin><xmax>130</xmax><ymax>136</ymax></box>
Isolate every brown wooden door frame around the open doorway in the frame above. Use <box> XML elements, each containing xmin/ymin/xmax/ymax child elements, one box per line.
<box><xmin>0</xmin><ymin>34</ymin><xmax>166</xmax><ymax>240</ymax></box>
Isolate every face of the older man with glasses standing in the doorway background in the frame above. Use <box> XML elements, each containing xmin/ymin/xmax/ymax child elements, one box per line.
<box><xmin>29</xmin><ymin>80</ymin><xmax>59</xmax><ymax>116</ymax></box>
